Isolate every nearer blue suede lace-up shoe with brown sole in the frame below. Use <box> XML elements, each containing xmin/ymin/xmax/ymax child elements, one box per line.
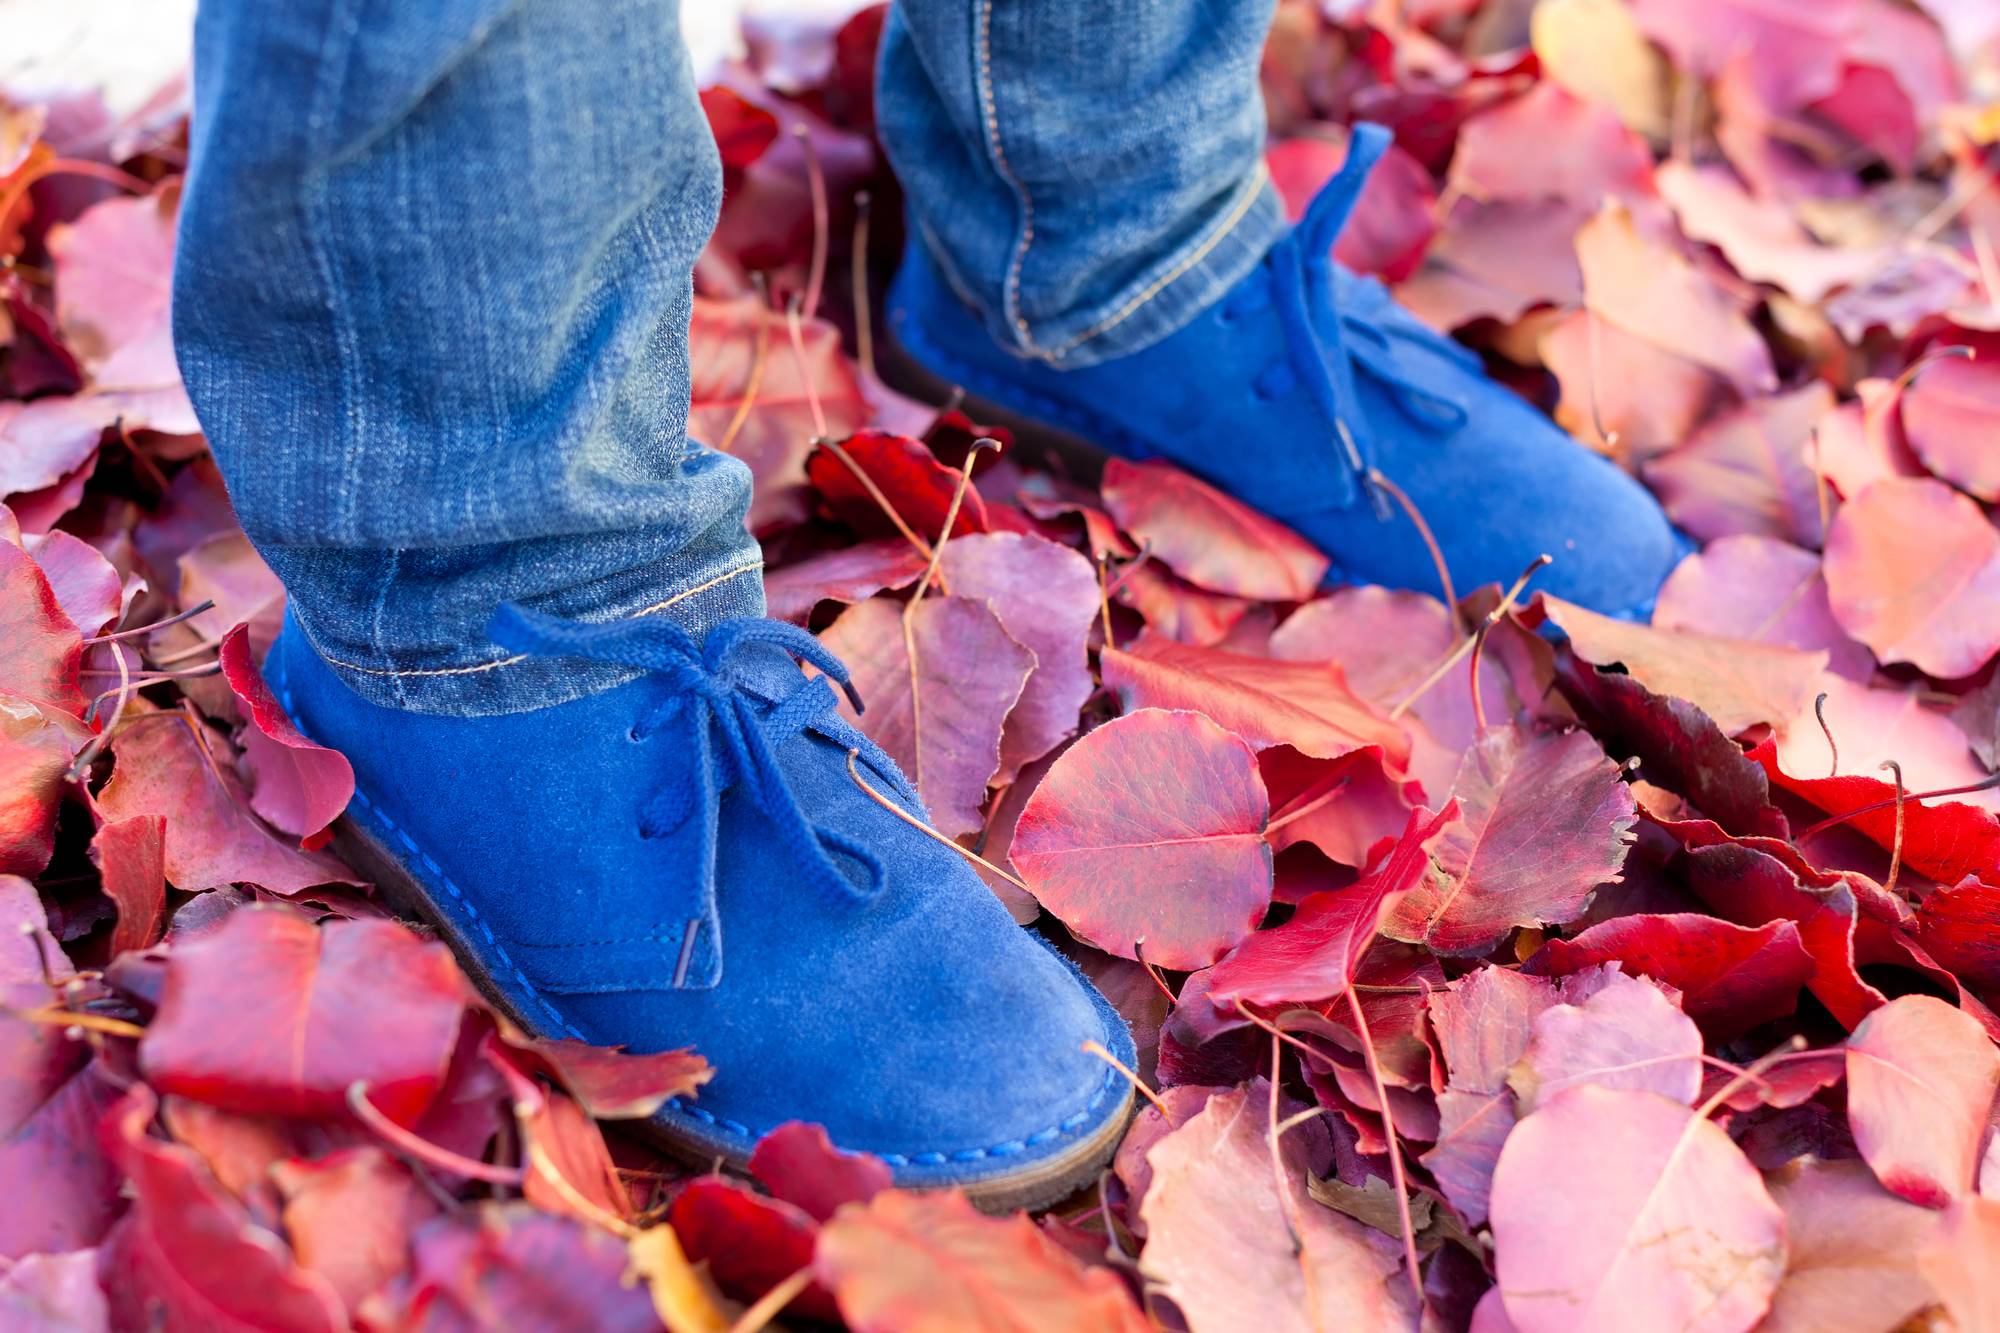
<box><xmin>266</xmin><ymin>608</ymin><xmax>1134</xmax><ymax>1209</ymax></box>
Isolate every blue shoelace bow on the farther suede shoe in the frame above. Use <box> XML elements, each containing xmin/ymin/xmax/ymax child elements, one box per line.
<box><xmin>1224</xmin><ymin>124</ymin><xmax>1478</xmax><ymax>518</ymax></box>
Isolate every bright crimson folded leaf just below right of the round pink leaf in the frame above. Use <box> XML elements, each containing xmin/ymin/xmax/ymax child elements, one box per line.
<box><xmin>1208</xmin><ymin>803</ymin><xmax>1458</xmax><ymax>1013</ymax></box>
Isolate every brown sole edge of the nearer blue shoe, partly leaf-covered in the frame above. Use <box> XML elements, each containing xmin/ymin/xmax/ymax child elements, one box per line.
<box><xmin>332</xmin><ymin>815</ymin><xmax>1134</xmax><ymax>1213</ymax></box>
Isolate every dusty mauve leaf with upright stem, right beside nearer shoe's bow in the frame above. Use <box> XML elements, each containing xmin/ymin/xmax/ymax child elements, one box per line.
<box><xmin>820</xmin><ymin>596</ymin><xmax>1034</xmax><ymax>837</ymax></box>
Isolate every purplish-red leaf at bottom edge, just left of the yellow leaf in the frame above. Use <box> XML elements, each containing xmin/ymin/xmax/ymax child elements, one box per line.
<box><xmin>368</xmin><ymin>1203</ymin><xmax>660</xmax><ymax>1333</ymax></box>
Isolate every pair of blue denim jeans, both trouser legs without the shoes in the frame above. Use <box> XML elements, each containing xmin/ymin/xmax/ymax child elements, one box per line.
<box><xmin>174</xmin><ymin>0</ymin><xmax>1284</xmax><ymax>715</ymax></box>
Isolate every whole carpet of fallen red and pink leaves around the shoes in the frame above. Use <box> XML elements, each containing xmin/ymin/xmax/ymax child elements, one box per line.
<box><xmin>0</xmin><ymin>0</ymin><xmax>2000</xmax><ymax>1333</ymax></box>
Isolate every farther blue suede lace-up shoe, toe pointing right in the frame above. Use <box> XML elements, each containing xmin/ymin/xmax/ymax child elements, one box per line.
<box><xmin>888</xmin><ymin>124</ymin><xmax>1692</xmax><ymax>618</ymax></box>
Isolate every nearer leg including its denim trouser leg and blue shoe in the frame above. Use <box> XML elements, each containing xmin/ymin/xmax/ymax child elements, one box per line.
<box><xmin>176</xmin><ymin>0</ymin><xmax>1136</xmax><ymax>1205</ymax></box>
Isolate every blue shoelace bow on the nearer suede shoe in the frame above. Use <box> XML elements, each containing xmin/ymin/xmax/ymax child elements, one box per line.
<box><xmin>488</xmin><ymin>604</ymin><xmax>884</xmax><ymax>901</ymax></box>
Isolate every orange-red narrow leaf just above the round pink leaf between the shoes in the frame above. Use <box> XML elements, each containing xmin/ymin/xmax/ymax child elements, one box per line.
<box><xmin>1100</xmin><ymin>636</ymin><xmax>1410</xmax><ymax>765</ymax></box>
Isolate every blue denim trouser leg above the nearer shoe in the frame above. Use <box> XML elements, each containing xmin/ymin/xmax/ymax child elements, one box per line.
<box><xmin>174</xmin><ymin>0</ymin><xmax>762</xmax><ymax>715</ymax></box>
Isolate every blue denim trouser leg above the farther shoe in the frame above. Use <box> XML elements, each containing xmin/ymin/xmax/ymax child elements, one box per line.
<box><xmin>876</xmin><ymin>0</ymin><xmax>1284</xmax><ymax>366</ymax></box>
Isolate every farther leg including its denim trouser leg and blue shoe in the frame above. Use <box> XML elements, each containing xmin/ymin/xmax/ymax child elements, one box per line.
<box><xmin>876</xmin><ymin>0</ymin><xmax>1686</xmax><ymax>616</ymax></box>
